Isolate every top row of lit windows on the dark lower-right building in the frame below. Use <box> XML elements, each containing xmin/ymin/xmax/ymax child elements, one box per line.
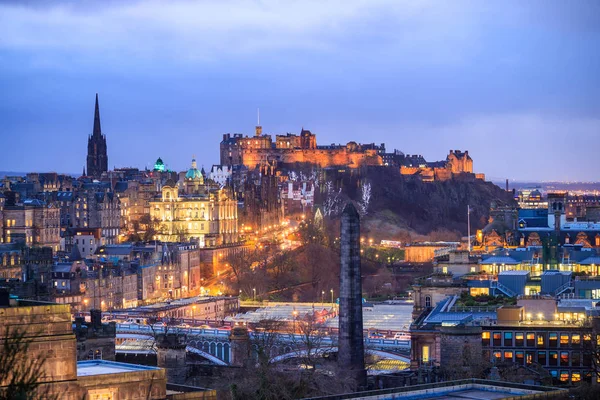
<box><xmin>481</xmin><ymin>331</ymin><xmax>592</xmax><ymax>348</ymax></box>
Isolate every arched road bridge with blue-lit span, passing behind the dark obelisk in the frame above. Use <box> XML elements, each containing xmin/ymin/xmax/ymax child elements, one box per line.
<box><xmin>116</xmin><ymin>324</ymin><xmax>410</xmax><ymax>365</ymax></box>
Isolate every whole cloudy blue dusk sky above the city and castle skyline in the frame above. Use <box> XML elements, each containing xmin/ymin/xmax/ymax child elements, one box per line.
<box><xmin>0</xmin><ymin>0</ymin><xmax>600</xmax><ymax>181</ymax></box>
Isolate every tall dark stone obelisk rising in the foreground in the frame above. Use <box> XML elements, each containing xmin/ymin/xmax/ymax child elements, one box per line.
<box><xmin>338</xmin><ymin>203</ymin><xmax>366</xmax><ymax>387</ymax></box>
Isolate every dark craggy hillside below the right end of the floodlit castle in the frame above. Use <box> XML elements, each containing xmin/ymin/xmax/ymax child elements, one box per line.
<box><xmin>316</xmin><ymin>168</ymin><xmax>514</xmax><ymax>241</ymax></box>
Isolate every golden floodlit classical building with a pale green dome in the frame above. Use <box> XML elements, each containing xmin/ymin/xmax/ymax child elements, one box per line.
<box><xmin>149</xmin><ymin>159</ymin><xmax>238</xmax><ymax>247</ymax></box>
